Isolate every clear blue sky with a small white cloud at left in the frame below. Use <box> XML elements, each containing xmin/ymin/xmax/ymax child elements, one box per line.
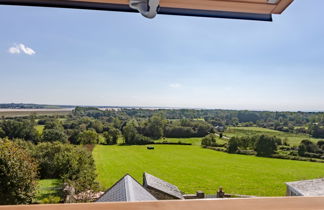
<box><xmin>0</xmin><ymin>0</ymin><xmax>324</xmax><ymax>111</ymax></box>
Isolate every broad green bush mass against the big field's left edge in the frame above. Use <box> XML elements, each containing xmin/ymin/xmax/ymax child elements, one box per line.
<box><xmin>34</xmin><ymin>142</ymin><xmax>98</xmax><ymax>192</ymax></box>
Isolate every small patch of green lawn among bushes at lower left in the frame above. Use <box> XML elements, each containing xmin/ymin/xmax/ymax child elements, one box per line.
<box><xmin>35</xmin><ymin>179</ymin><xmax>62</xmax><ymax>203</ymax></box>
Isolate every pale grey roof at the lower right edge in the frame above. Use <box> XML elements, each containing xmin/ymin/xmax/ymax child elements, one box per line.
<box><xmin>286</xmin><ymin>179</ymin><xmax>324</xmax><ymax>196</ymax></box>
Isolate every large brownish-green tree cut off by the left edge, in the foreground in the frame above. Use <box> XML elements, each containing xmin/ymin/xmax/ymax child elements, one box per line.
<box><xmin>0</xmin><ymin>140</ymin><xmax>37</xmax><ymax>205</ymax></box>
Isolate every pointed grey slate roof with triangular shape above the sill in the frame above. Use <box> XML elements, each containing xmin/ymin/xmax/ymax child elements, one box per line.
<box><xmin>96</xmin><ymin>174</ymin><xmax>156</xmax><ymax>202</ymax></box>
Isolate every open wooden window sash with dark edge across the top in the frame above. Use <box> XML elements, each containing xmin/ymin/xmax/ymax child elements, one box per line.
<box><xmin>0</xmin><ymin>0</ymin><xmax>293</xmax><ymax>21</ymax></box>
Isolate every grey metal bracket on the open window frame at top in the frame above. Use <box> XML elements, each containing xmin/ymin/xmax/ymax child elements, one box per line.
<box><xmin>129</xmin><ymin>0</ymin><xmax>160</xmax><ymax>18</ymax></box>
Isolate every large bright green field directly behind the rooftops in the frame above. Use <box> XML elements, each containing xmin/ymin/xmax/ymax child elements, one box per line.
<box><xmin>93</xmin><ymin>145</ymin><xmax>324</xmax><ymax>196</ymax></box>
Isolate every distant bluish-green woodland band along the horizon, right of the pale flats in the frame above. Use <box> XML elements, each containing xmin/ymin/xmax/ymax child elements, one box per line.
<box><xmin>74</xmin><ymin>107</ymin><xmax>324</xmax><ymax>138</ymax></box>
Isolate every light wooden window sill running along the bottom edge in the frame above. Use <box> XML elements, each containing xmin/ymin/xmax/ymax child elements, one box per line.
<box><xmin>0</xmin><ymin>197</ymin><xmax>324</xmax><ymax>210</ymax></box>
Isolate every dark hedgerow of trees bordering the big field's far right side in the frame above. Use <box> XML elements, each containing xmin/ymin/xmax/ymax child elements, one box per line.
<box><xmin>201</xmin><ymin>134</ymin><xmax>324</xmax><ymax>162</ymax></box>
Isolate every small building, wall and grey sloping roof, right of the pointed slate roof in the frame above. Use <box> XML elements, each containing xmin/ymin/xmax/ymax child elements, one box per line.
<box><xmin>143</xmin><ymin>173</ymin><xmax>184</xmax><ymax>200</ymax></box>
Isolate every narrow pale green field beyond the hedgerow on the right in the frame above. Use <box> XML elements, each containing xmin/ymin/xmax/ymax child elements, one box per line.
<box><xmin>224</xmin><ymin>127</ymin><xmax>323</xmax><ymax>145</ymax></box>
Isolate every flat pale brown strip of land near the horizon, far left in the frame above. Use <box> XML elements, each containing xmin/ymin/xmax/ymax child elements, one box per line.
<box><xmin>0</xmin><ymin>108</ymin><xmax>73</xmax><ymax>117</ymax></box>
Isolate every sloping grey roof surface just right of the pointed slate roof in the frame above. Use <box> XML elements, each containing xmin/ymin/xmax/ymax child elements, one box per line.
<box><xmin>143</xmin><ymin>172</ymin><xmax>184</xmax><ymax>199</ymax></box>
